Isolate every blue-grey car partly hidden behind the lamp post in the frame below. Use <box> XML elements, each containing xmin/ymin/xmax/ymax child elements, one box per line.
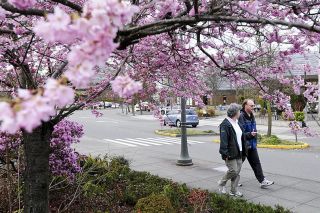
<box><xmin>163</xmin><ymin>109</ymin><xmax>199</xmax><ymax>127</ymax></box>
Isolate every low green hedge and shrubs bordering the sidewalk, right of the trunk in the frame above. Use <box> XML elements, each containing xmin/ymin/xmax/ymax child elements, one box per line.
<box><xmin>50</xmin><ymin>157</ymin><xmax>289</xmax><ymax>213</ymax></box>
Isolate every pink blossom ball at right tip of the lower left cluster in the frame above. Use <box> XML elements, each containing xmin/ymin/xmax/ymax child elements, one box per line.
<box><xmin>44</xmin><ymin>78</ymin><xmax>74</xmax><ymax>108</ymax></box>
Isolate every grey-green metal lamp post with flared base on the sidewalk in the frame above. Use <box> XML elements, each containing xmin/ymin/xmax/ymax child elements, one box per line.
<box><xmin>177</xmin><ymin>97</ymin><xmax>193</xmax><ymax>166</ymax></box>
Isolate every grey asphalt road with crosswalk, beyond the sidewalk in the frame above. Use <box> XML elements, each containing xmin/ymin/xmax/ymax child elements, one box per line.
<box><xmin>70</xmin><ymin>109</ymin><xmax>320</xmax><ymax>181</ymax></box>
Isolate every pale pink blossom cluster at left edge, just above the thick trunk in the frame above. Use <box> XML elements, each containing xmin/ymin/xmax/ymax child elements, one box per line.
<box><xmin>0</xmin><ymin>79</ymin><xmax>74</xmax><ymax>134</ymax></box>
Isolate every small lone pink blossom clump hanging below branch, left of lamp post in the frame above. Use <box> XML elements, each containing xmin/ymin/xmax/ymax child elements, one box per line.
<box><xmin>111</xmin><ymin>75</ymin><xmax>142</xmax><ymax>98</ymax></box>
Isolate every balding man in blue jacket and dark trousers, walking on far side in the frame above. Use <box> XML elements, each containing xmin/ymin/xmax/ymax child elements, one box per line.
<box><xmin>239</xmin><ymin>99</ymin><xmax>274</xmax><ymax>188</ymax></box>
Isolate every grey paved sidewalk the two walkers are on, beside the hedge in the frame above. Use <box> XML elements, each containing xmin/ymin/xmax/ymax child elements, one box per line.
<box><xmin>131</xmin><ymin>154</ymin><xmax>320</xmax><ymax>213</ymax></box>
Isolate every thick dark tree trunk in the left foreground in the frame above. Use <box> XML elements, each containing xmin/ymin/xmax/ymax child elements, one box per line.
<box><xmin>23</xmin><ymin>123</ymin><xmax>53</xmax><ymax>213</ymax></box>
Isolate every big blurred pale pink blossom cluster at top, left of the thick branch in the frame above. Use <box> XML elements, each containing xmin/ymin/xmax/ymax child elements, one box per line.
<box><xmin>34</xmin><ymin>0</ymin><xmax>138</xmax><ymax>87</ymax></box>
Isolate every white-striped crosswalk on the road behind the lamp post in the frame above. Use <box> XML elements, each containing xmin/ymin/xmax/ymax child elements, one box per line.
<box><xmin>103</xmin><ymin>137</ymin><xmax>205</xmax><ymax>147</ymax></box>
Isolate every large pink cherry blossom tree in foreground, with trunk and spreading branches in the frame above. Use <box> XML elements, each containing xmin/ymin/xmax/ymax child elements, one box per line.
<box><xmin>0</xmin><ymin>0</ymin><xmax>320</xmax><ymax>212</ymax></box>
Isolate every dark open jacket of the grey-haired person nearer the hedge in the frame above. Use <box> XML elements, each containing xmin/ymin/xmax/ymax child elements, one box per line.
<box><xmin>219</xmin><ymin>118</ymin><xmax>253</xmax><ymax>160</ymax></box>
